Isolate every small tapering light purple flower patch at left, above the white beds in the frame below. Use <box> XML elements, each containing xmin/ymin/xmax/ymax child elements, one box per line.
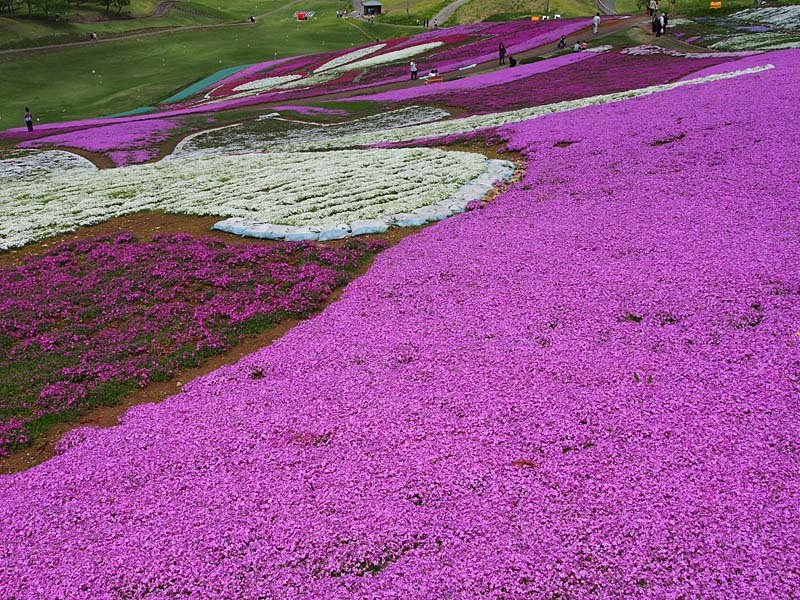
<box><xmin>19</xmin><ymin>119</ymin><xmax>180</xmax><ymax>167</ymax></box>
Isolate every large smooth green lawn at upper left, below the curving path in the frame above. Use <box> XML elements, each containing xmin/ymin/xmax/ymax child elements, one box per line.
<box><xmin>0</xmin><ymin>1</ymin><xmax>404</xmax><ymax>130</ymax></box>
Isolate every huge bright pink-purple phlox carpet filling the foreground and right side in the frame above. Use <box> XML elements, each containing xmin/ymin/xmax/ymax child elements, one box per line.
<box><xmin>0</xmin><ymin>52</ymin><xmax>800</xmax><ymax>600</ymax></box>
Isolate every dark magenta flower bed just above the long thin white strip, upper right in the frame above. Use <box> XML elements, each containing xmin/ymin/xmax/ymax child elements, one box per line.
<box><xmin>400</xmin><ymin>53</ymin><xmax>736</xmax><ymax>113</ymax></box>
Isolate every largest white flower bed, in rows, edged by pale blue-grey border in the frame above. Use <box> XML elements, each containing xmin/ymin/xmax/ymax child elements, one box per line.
<box><xmin>0</xmin><ymin>148</ymin><xmax>487</xmax><ymax>249</ymax></box>
